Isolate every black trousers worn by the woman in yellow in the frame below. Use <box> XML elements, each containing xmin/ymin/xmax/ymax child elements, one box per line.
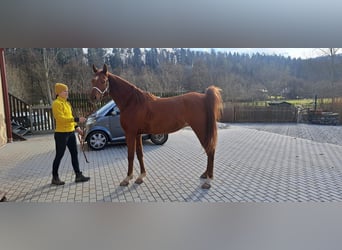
<box><xmin>52</xmin><ymin>132</ymin><xmax>81</xmax><ymax>177</ymax></box>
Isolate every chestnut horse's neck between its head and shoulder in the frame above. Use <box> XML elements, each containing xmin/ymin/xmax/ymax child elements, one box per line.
<box><xmin>108</xmin><ymin>74</ymin><xmax>134</xmax><ymax>112</ymax></box>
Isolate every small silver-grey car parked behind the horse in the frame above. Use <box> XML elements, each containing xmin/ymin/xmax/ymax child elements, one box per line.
<box><xmin>84</xmin><ymin>100</ymin><xmax>168</xmax><ymax>150</ymax></box>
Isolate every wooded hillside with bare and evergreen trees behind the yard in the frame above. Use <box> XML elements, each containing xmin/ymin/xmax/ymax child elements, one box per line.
<box><xmin>5</xmin><ymin>48</ymin><xmax>342</xmax><ymax>104</ymax></box>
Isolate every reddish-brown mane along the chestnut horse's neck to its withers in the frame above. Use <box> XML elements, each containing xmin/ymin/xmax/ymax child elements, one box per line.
<box><xmin>109</xmin><ymin>73</ymin><xmax>157</xmax><ymax>104</ymax></box>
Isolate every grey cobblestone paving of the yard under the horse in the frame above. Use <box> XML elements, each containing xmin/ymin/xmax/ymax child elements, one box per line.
<box><xmin>0</xmin><ymin>124</ymin><xmax>342</xmax><ymax>202</ymax></box>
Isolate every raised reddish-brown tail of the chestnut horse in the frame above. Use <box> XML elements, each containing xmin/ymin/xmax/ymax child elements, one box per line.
<box><xmin>204</xmin><ymin>86</ymin><xmax>223</xmax><ymax>152</ymax></box>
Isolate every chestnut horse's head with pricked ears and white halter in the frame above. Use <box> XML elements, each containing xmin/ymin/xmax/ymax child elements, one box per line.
<box><xmin>90</xmin><ymin>64</ymin><xmax>109</xmax><ymax>101</ymax></box>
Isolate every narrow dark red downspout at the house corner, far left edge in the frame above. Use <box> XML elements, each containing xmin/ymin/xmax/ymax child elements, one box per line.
<box><xmin>0</xmin><ymin>48</ymin><xmax>13</xmax><ymax>142</ymax></box>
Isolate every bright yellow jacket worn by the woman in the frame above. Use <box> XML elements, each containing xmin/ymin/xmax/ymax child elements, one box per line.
<box><xmin>52</xmin><ymin>96</ymin><xmax>78</xmax><ymax>132</ymax></box>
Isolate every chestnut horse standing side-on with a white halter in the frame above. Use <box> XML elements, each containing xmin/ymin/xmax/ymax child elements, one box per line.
<box><xmin>91</xmin><ymin>65</ymin><xmax>222</xmax><ymax>189</ymax></box>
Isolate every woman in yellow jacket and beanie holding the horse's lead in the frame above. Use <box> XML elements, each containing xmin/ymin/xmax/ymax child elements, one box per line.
<box><xmin>51</xmin><ymin>83</ymin><xmax>90</xmax><ymax>185</ymax></box>
